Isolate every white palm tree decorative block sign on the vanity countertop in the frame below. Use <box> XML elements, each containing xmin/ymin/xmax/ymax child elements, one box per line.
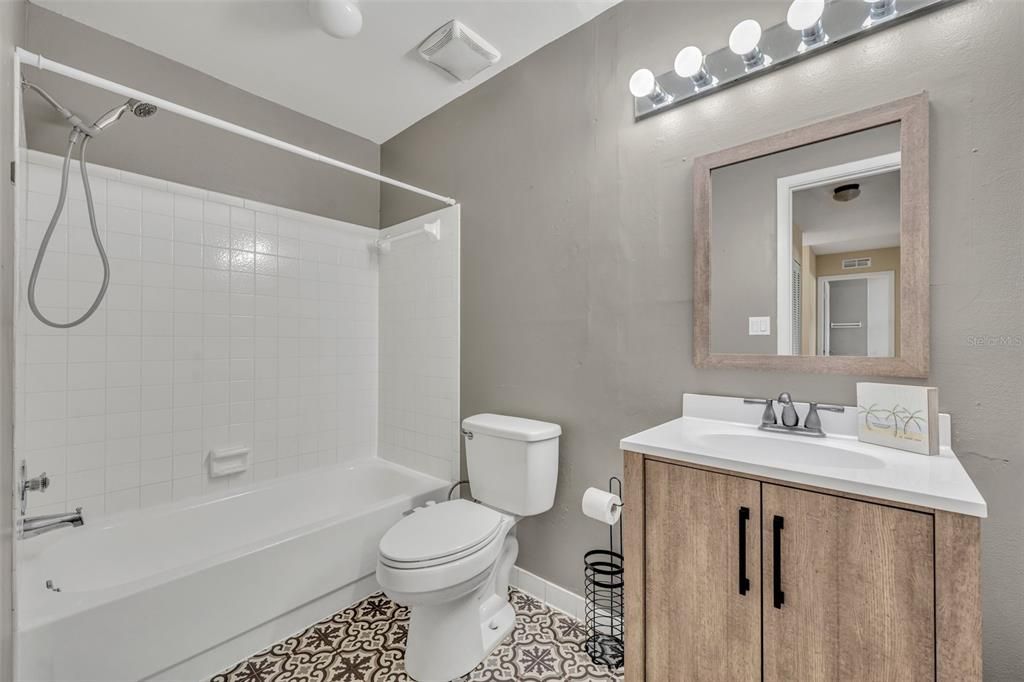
<box><xmin>857</xmin><ymin>382</ymin><xmax>939</xmax><ymax>455</ymax></box>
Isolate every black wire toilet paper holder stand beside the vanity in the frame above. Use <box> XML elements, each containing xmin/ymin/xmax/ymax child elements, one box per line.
<box><xmin>583</xmin><ymin>476</ymin><xmax>626</xmax><ymax>669</ymax></box>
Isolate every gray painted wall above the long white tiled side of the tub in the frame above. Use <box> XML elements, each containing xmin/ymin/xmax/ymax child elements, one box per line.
<box><xmin>24</xmin><ymin>5</ymin><xmax>380</xmax><ymax>227</ymax></box>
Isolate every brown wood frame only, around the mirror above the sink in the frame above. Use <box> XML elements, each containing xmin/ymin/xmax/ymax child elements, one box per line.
<box><xmin>693</xmin><ymin>92</ymin><xmax>929</xmax><ymax>378</ymax></box>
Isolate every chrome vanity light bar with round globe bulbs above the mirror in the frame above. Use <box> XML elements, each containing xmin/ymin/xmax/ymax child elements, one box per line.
<box><xmin>630</xmin><ymin>0</ymin><xmax>962</xmax><ymax>121</ymax></box>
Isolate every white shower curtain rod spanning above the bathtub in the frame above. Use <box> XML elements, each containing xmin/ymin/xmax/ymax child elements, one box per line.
<box><xmin>14</xmin><ymin>47</ymin><xmax>458</xmax><ymax>206</ymax></box>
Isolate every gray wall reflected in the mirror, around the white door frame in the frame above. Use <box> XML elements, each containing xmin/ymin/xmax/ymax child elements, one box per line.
<box><xmin>711</xmin><ymin>124</ymin><xmax>899</xmax><ymax>355</ymax></box>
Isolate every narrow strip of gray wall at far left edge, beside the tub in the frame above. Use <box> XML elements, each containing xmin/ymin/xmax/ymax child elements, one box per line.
<box><xmin>0</xmin><ymin>0</ymin><xmax>26</xmax><ymax>682</ymax></box>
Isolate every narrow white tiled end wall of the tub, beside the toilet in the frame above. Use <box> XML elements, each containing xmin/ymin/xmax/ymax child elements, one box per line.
<box><xmin>379</xmin><ymin>206</ymin><xmax>461</xmax><ymax>480</ymax></box>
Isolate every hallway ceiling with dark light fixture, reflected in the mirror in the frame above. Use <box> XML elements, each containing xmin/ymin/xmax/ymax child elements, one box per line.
<box><xmin>793</xmin><ymin>171</ymin><xmax>900</xmax><ymax>255</ymax></box>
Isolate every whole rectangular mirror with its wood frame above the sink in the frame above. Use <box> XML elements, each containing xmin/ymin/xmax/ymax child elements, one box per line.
<box><xmin>693</xmin><ymin>93</ymin><xmax>929</xmax><ymax>377</ymax></box>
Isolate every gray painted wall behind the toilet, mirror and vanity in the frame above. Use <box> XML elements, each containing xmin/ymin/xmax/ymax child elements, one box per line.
<box><xmin>382</xmin><ymin>0</ymin><xmax>1024</xmax><ymax>680</ymax></box>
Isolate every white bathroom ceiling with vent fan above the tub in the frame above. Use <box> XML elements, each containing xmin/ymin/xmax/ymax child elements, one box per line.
<box><xmin>33</xmin><ymin>0</ymin><xmax>620</xmax><ymax>142</ymax></box>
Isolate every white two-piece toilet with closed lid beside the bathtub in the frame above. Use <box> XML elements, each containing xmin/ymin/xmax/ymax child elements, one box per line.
<box><xmin>377</xmin><ymin>415</ymin><xmax>562</xmax><ymax>682</ymax></box>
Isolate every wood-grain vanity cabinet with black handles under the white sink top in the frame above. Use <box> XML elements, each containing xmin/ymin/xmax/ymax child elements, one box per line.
<box><xmin>624</xmin><ymin>453</ymin><xmax>981</xmax><ymax>682</ymax></box>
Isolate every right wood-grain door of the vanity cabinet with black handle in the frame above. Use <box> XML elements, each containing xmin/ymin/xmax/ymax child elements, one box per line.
<box><xmin>762</xmin><ymin>483</ymin><xmax>935</xmax><ymax>682</ymax></box>
